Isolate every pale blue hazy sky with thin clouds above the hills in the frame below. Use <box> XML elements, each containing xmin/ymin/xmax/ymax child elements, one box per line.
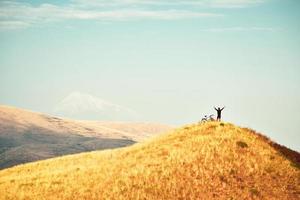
<box><xmin>0</xmin><ymin>0</ymin><xmax>300</xmax><ymax>151</ymax></box>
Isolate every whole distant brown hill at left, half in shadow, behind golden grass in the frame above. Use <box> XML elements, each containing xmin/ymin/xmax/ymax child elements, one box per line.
<box><xmin>0</xmin><ymin>106</ymin><xmax>170</xmax><ymax>169</ymax></box>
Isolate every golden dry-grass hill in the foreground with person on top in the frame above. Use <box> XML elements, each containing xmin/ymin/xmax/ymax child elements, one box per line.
<box><xmin>0</xmin><ymin>122</ymin><xmax>300</xmax><ymax>200</ymax></box>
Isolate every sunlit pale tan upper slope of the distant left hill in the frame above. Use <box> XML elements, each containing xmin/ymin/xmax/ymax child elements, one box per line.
<box><xmin>0</xmin><ymin>105</ymin><xmax>171</xmax><ymax>141</ymax></box>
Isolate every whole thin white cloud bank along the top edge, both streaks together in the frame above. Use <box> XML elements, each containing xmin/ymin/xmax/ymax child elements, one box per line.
<box><xmin>0</xmin><ymin>0</ymin><xmax>264</xmax><ymax>29</ymax></box>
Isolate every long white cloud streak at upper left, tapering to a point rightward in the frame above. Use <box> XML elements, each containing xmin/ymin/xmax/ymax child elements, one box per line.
<box><xmin>0</xmin><ymin>0</ymin><xmax>221</xmax><ymax>29</ymax></box>
